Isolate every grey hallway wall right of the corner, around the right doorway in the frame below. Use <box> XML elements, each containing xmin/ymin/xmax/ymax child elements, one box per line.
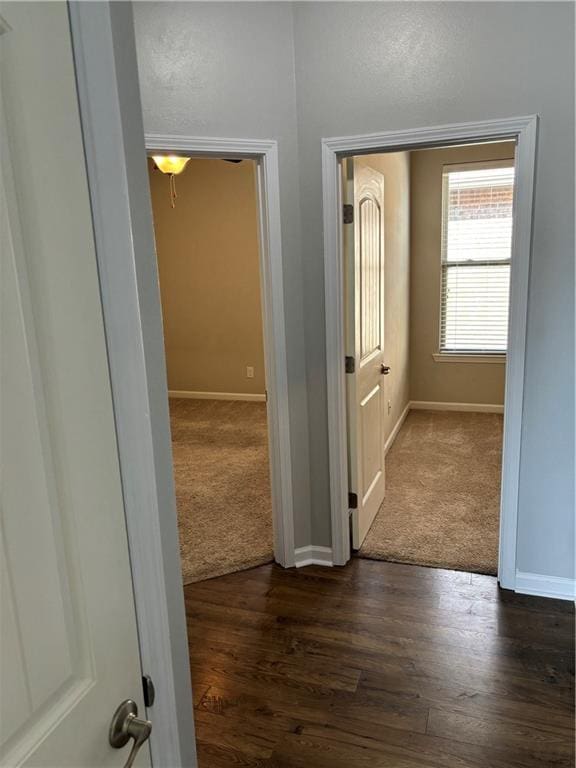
<box><xmin>294</xmin><ymin>2</ymin><xmax>574</xmax><ymax>576</ymax></box>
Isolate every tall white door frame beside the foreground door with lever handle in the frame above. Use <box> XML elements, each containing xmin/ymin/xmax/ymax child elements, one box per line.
<box><xmin>68</xmin><ymin>2</ymin><xmax>197</xmax><ymax>768</ymax></box>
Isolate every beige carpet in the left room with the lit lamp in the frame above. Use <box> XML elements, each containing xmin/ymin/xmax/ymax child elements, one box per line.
<box><xmin>170</xmin><ymin>399</ymin><xmax>274</xmax><ymax>584</ymax></box>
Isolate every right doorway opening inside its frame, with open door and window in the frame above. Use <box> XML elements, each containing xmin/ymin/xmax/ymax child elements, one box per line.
<box><xmin>342</xmin><ymin>141</ymin><xmax>515</xmax><ymax>575</ymax></box>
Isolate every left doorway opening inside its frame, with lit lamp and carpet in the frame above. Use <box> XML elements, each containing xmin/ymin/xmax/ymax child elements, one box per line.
<box><xmin>148</xmin><ymin>155</ymin><xmax>274</xmax><ymax>584</ymax></box>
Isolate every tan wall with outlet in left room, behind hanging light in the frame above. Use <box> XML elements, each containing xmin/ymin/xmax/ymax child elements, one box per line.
<box><xmin>149</xmin><ymin>159</ymin><xmax>266</xmax><ymax>393</ymax></box>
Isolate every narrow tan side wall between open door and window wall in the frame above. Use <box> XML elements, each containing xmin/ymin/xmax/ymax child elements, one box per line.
<box><xmin>359</xmin><ymin>152</ymin><xmax>410</xmax><ymax>439</ymax></box>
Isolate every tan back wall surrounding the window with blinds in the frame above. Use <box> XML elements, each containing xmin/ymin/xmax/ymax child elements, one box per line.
<box><xmin>410</xmin><ymin>142</ymin><xmax>514</xmax><ymax>404</ymax></box>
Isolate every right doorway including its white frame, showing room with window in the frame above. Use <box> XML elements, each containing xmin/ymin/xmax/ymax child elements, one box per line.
<box><xmin>323</xmin><ymin>118</ymin><xmax>536</xmax><ymax>588</ymax></box>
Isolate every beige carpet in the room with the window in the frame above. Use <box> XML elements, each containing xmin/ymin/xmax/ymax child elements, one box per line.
<box><xmin>358</xmin><ymin>411</ymin><xmax>502</xmax><ymax>574</ymax></box>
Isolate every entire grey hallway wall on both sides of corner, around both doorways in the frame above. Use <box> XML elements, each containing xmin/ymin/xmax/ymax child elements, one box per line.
<box><xmin>135</xmin><ymin>2</ymin><xmax>574</xmax><ymax>576</ymax></box>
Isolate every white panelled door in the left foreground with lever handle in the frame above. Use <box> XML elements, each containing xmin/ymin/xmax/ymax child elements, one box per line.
<box><xmin>0</xmin><ymin>2</ymin><xmax>150</xmax><ymax>768</ymax></box>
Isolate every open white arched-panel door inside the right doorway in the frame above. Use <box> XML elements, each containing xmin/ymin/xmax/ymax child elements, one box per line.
<box><xmin>343</xmin><ymin>158</ymin><xmax>388</xmax><ymax>549</ymax></box>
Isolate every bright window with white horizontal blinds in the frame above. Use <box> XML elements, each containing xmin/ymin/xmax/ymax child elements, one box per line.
<box><xmin>440</xmin><ymin>161</ymin><xmax>514</xmax><ymax>355</ymax></box>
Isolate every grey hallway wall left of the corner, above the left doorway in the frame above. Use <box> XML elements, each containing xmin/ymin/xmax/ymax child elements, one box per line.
<box><xmin>134</xmin><ymin>2</ymin><xmax>310</xmax><ymax>547</ymax></box>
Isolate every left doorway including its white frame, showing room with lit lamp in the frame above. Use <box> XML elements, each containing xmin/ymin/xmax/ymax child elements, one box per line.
<box><xmin>146</xmin><ymin>136</ymin><xmax>294</xmax><ymax>584</ymax></box>
